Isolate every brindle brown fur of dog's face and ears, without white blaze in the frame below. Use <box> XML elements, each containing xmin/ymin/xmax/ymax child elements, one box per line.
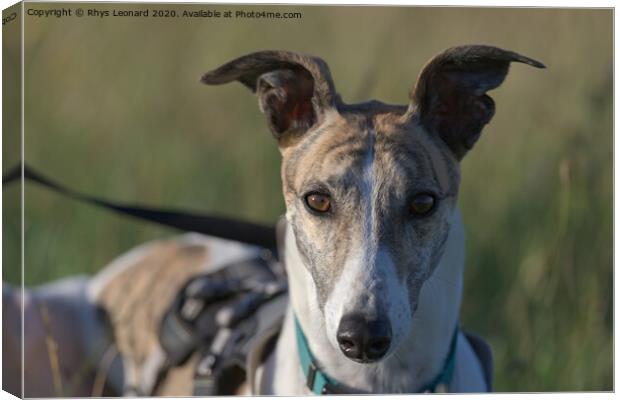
<box><xmin>203</xmin><ymin>46</ymin><xmax>542</xmax><ymax>307</ymax></box>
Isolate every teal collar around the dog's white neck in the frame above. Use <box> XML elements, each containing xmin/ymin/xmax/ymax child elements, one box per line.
<box><xmin>295</xmin><ymin>317</ymin><xmax>459</xmax><ymax>395</ymax></box>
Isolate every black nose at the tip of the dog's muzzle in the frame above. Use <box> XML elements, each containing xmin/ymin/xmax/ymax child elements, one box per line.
<box><xmin>337</xmin><ymin>314</ymin><xmax>392</xmax><ymax>363</ymax></box>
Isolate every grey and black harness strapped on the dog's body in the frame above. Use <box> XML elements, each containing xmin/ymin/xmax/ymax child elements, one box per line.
<box><xmin>140</xmin><ymin>253</ymin><xmax>288</xmax><ymax>396</ymax></box>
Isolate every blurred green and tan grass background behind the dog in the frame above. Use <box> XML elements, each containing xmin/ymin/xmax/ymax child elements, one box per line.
<box><xmin>4</xmin><ymin>3</ymin><xmax>613</xmax><ymax>391</ymax></box>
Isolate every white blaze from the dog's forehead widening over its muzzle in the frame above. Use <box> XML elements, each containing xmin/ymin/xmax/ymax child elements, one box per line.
<box><xmin>324</xmin><ymin>131</ymin><xmax>412</xmax><ymax>355</ymax></box>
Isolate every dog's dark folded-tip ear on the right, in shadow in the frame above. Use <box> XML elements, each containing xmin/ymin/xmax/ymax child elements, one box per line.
<box><xmin>410</xmin><ymin>45</ymin><xmax>545</xmax><ymax>160</ymax></box>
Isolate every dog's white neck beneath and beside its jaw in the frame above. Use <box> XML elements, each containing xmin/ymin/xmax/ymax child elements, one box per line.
<box><xmin>270</xmin><ymin>210</ymin><xmax>464</xmax><ymax>395</ymax></box>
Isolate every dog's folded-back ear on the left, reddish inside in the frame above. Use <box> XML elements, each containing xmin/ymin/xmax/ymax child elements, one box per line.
<box><xmin>202</xmin><ymin>51</ymin><xmax>337</xmax><ymax>147</ymax></box>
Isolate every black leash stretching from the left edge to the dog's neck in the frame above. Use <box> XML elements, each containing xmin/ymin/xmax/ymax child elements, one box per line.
<box><xmin>2</xmin><ymin>164</ymin><xmax>276</xmax><ymax>249</ymax></box>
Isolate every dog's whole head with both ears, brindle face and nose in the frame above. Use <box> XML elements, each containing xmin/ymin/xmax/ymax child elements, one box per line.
<box><xmin>203</xmin><ymin>46</ymin><xmax>543</xmax><ymax>363</ymax></box>
